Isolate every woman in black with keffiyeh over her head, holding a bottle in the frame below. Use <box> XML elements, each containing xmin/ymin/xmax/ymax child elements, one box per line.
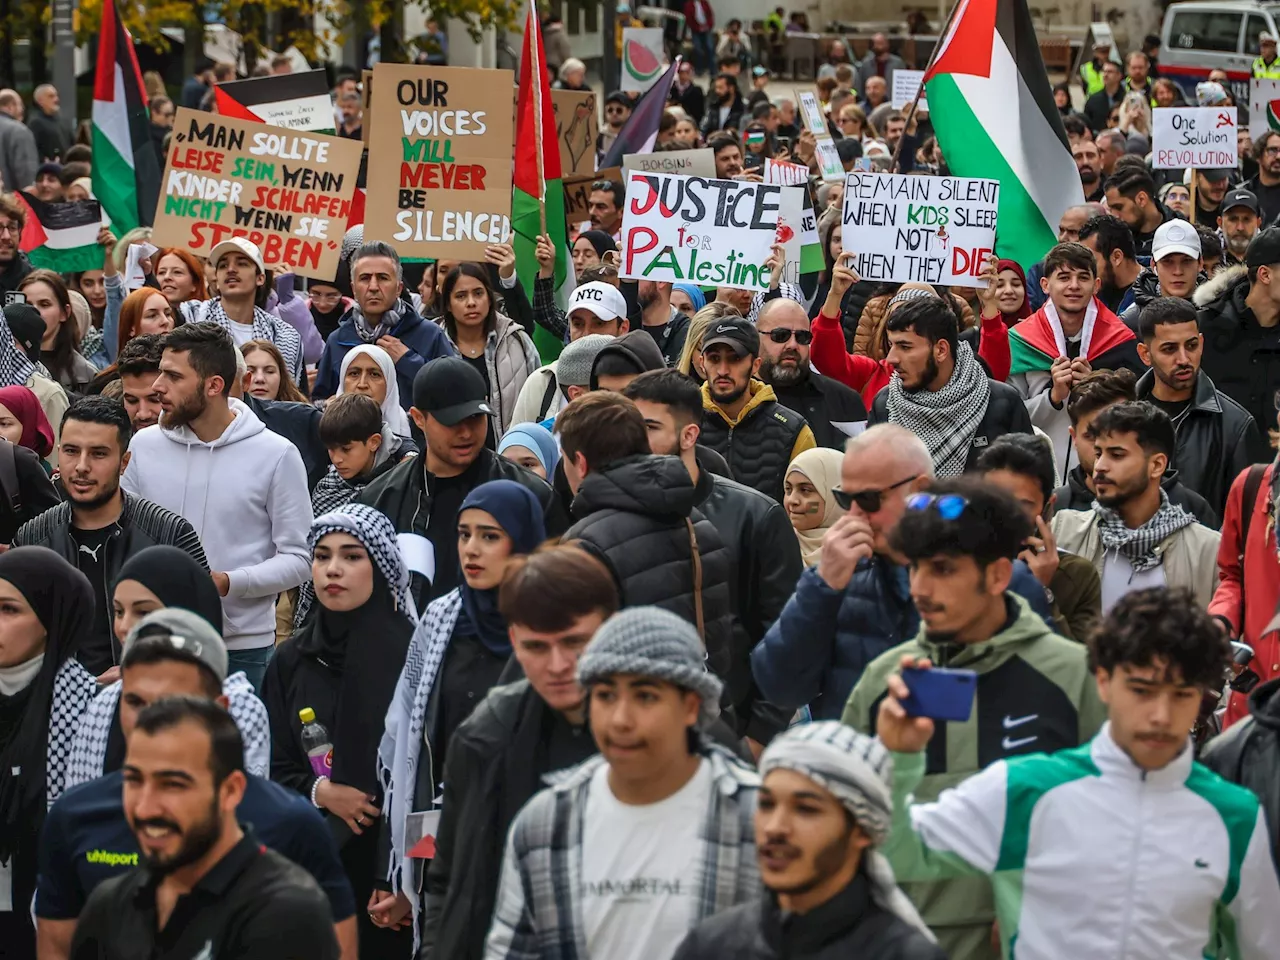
<box><xmin>262</xmin><ymin>503</ymin><xmax>415</xmax><ymax>957</ymax></box>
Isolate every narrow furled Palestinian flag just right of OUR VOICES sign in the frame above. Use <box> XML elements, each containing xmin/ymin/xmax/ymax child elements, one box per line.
<box><xmin>511</xmin><ymin>5</ymin><xmax>570</xmax><ymax>364</ymax></box>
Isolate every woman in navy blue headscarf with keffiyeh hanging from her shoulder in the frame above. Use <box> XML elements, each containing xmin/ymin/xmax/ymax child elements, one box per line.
<box><xmin>378</xmin><ymin>480</ymin><xmax>547</xmax><ymax>941</ymax></box>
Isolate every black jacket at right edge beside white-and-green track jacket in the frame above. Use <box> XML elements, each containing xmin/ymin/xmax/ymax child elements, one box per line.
<box><xmin>1199</xmin><ymin>680</ymin><xmax>1280</xmax><ymax>869</ymax></box>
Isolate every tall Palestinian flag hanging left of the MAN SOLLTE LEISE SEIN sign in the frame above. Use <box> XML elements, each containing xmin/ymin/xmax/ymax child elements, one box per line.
<box><xmin>93</xmin><ymin>0</ymin><xmax>161</xmax><ymax>236</ymax></box>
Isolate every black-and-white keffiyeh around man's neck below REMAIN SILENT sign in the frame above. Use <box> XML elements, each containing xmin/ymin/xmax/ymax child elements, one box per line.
<box><xmin>888</xmin><ymin>343</ymin><xmax>991</xmax><ymax>477</ymax></box>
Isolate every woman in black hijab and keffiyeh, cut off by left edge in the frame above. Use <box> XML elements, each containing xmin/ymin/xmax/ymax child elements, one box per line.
<box><xmin>0</xmin><ymin>547</ymin><xmax>97</xmax><ymax>957</ymax></box>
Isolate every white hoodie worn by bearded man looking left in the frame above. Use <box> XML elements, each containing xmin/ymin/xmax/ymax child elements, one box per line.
<box><xmin>122</xmin><ymin>399</ymin><xmax>312</xmax><ymax>650</ymax></box>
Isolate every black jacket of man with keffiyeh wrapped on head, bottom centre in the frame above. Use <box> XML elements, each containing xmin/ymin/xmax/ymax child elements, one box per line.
<box><xmin>673</xmin><ymin>873</ymin><xmax>946</xmax><ymax>960</ymax></box>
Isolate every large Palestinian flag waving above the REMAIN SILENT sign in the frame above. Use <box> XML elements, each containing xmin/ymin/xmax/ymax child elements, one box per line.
<box><xmin>924</xmin><ymin>0</ymin><xmax>1084</xmax><ymax>269</ymax></box>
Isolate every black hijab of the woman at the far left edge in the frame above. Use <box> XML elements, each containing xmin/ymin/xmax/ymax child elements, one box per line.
<box><xmin>0</xmin><ymin>547</ymin><xmax>93</xmax><ymax>860</ymax></box>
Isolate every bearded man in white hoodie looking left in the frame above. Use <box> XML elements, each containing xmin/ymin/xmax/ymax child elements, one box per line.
<box><xmin>120</xmin><ymin>324</ymin><xmax>312</xmax><ymax>687</ymax></box>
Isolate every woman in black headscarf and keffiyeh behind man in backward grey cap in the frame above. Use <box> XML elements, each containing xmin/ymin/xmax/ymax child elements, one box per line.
<box><xmin>67</xmin><ymin>547</ymin><xmax>271</xmax><ymax>787</ymax></box>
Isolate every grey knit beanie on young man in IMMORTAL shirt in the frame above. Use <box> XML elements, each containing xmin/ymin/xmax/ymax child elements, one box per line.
<box><xmin>577</xmin><ymin>607</ymin><xmax>723</xmax><ymax>726</ymax></box>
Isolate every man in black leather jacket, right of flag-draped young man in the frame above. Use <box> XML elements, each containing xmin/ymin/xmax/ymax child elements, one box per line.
<box><xmin>1138</xmin><ymin>297</ymin><xmax>1271</xmax><ymax>516</ymax></box>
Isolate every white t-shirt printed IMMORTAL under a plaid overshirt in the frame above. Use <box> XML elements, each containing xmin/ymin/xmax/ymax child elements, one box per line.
<box><xmin>582</xmin><ymin>760</ymin><xmax>712</xmax><ymax>960</ymax></box>
